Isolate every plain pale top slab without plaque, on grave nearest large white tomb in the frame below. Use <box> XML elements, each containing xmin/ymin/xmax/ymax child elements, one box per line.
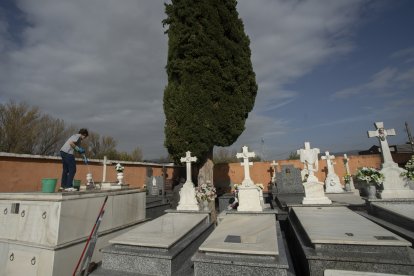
<box><xmin>109</xmin><ymin>213</ymin><xmax>208</xmax><ymax>248</ymax></box>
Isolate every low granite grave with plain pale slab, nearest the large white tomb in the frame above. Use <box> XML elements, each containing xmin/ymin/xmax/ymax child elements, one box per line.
<box><xmin>97</xmin><ymin>212</ymin><xmax>214</xmax><ymax>275</ymax></box>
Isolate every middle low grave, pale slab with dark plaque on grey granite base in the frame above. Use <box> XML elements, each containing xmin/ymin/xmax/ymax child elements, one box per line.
<box><xmin>191</xmin><ymin>213</ymin><xmax>289</xmax><ymax>275</ymax></box>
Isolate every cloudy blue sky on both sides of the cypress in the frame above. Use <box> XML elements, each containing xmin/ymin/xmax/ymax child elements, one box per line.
<box><xmin>0</xmin><ymin>0</ymin><xmax>414</xmax><ymax>160</ymax></box>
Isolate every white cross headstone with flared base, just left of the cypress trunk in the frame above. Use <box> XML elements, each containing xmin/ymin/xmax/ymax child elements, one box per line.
<box><xmin>177</xmin><ymin>151</ymin><xmax>199</xmax><ymax>211</ymax></box>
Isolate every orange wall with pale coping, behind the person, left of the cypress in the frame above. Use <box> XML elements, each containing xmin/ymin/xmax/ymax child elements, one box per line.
<box><xmin>0</xmin><ymin>153</ymin><xmax>182</xmax><ymax>192</ymax></box>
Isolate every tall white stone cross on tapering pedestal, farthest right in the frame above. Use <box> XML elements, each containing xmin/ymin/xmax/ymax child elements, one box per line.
<box><xmin>368</xmin><ymin>122</ymin><xmax>414</xmax><ymax>199</ymax></box>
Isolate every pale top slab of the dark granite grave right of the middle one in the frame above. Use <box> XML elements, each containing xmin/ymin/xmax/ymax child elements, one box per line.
<box><xmin>292</xmin><ymin>207</ymin><xmax>411</xmax><ymax>246</ymax></box>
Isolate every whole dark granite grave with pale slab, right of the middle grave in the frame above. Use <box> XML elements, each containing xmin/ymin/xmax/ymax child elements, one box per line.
<box><xmin>285</xmin><ymin>206</ymin><xmax>414</xmax><ymax>275</ymax></box>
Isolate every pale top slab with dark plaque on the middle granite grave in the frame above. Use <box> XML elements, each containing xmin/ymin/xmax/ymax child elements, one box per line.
<box><xmin>199</xmin><ymin>214</ymin><xmax>279</xmax><ymax>255</ymax></box>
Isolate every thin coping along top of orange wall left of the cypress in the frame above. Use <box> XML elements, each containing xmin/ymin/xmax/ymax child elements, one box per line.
<box><xmin>0</xmin><ymin>152</ymin><xmax>176</xmax><ymax>167</ymax></box>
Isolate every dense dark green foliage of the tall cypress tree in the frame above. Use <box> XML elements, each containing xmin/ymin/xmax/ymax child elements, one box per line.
<box><xmin>163</xmin><ymin>0</ymin><xmax>257</xmax><ymax>176</ymax></box>
